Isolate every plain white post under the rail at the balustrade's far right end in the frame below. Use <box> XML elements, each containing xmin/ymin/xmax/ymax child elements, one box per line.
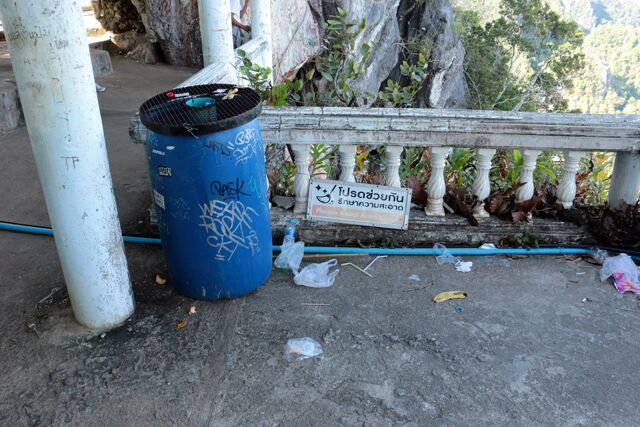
<box><xmin>607</xmin><ymin>152</ymin><xmax>640</xmax><ymax>209</ymax></box>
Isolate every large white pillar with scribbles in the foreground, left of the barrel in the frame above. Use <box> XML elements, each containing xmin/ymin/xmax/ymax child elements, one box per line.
<box><xmin>0</xmin><ymin>0</ymin><xmax>134</xmax><ymax>329</ymax></box>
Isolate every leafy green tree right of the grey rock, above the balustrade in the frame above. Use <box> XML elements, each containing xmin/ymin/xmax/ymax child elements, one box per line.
<box><xmin>456</xmin><ymin>0</ymin><xmax>584</xmax><ymax>111</ymax></box>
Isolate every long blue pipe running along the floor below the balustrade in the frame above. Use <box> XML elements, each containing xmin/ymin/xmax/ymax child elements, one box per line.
<box><xmin>0</xmin><ymin>222</ymin><xmax>637</xmax><ymax>258</ymax></box>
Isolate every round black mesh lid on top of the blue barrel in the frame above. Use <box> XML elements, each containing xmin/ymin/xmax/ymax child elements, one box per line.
<box><xmin>140</xmin><ymin>84</ymin><xmax>262</xmax><ymax>136</ymax></box>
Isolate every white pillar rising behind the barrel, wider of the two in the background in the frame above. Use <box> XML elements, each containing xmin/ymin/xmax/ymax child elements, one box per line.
<box><xmin>198</xmin><ymin>0</ymin><xmax>237</xmax><ymax>75</ymax></box>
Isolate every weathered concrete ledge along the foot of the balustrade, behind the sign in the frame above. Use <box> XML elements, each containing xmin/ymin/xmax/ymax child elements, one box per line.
<box><xmin>271</xmin><ymin>208</ymin><xmax>596</xmax><ymax>247</ymax></box>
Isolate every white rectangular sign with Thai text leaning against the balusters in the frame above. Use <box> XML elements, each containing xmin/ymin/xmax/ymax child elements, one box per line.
<box><xmin>307</xmin><ymin>179</ymin><xmax>411</xmax><ymax>230</ymax></box>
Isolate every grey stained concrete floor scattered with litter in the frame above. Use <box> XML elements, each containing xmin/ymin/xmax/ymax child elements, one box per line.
<box><xmin>0</xmin><ymin>59</ymin><xmax>640</xmax><ymax>426</ymax></box>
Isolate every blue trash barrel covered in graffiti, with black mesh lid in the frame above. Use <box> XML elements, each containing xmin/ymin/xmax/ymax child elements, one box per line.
<box><xmin>140</xmin><ymin>84</ymin><xmax>272</xmax><ymax>300</ymax></box>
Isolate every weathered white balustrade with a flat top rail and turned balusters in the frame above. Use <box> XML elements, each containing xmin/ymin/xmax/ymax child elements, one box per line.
<box><xmin>261</xmin><ymin>108</ymin><xmax>640</xmax><ymax>217</ymax></box>
